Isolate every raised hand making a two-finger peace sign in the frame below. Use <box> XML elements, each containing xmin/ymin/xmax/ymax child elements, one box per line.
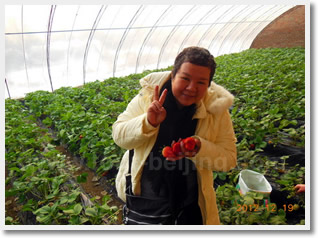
<box><xmin>147</xmin><ymin>85</ymin><xmax>168</xmax><ymax>127</ymax></box>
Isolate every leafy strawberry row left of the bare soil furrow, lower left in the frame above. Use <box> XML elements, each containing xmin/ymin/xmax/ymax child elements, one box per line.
<box><xmin>6</xmin><ymin>100</ymin><xmax>117</xmax><ymax>225</ymax></box>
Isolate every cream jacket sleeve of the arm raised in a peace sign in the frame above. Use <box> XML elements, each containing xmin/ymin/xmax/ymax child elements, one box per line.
<box><xmin>112</xmin><ymin>94</ymin><xmax>158</xmax><ymax>150</ymax></box>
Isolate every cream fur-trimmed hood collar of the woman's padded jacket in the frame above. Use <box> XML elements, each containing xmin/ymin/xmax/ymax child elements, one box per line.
<box><xmin>140</xmin><ymin>71</ymin><xmax>234</xmax><ymax>119</ymax></box>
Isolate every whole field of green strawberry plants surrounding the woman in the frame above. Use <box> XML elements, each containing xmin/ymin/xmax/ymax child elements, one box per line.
<box><xmin>5</xmin><ymin>48</ymin><xmax>305</xmax><ymax>225</ymax></box>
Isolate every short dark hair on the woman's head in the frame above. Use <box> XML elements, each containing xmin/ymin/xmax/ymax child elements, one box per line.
<box><xmin>171</xmin><ymin>46</ymin><xmax>216</xmax><ymax>83</ymax></box>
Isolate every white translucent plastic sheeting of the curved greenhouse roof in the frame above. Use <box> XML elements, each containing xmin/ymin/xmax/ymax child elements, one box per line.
<box><xmin>5</xmin><ymin>5</ymin><xmax>294</xmax><ymax>98</ymax></box>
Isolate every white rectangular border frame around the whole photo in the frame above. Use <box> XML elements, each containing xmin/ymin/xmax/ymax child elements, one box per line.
<box><xmin>0</xmin><ymin>0</ymin><xmax>315</xmax><ymax>232</ymax></box>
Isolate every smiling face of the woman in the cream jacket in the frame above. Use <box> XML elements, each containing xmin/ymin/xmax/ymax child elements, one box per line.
<box><xmin>172</xmin><ymin>62</ymin><xmax>211</xmax><ymax>106</ymax></box>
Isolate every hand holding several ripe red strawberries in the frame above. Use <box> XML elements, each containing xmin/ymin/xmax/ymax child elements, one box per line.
<box><xmin>162</xmin><ymin>137</ymin><xmax>201</xmax><ymax>161</ymax></box>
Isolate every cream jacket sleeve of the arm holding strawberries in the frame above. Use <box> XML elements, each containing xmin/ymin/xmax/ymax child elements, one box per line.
<box><xmin>190</xmin><ymin>111</ymin><xmax>237</xmax><ymax>171</ymax></box>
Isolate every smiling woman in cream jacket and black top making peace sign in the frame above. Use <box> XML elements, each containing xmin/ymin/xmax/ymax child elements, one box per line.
<box><xmin>113</xmin><ymin>47</ymin><xmax>236</xmax><ymax>225</ymax></box>
